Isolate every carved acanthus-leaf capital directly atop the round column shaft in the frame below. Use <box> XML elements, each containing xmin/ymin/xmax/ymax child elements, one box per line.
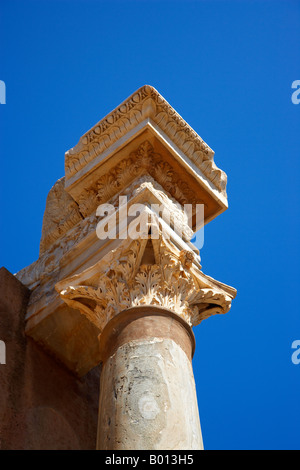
<box><xmin>56</xmin><ymin>235</ymin><xmax>233</xmax><ymax>331</ymax></box>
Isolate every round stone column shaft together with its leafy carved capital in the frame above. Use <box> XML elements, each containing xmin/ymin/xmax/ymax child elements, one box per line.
<box><xmin>57</xmin><ymin>237</ymin><xmax>234</xmax><ymax>450</ymax></box>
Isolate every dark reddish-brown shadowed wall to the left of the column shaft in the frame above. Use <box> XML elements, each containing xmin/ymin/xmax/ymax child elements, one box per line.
<box><xmin>0</xmin><ymin>268</ymin><xmax>100</xmax><ymax>450</ymax></box>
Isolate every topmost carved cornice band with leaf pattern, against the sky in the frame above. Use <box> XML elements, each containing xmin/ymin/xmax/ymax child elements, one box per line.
<box><xmin>65</xmin><ymin>85</ymin><xmax>227</xmax><ymax>194</ymax></box>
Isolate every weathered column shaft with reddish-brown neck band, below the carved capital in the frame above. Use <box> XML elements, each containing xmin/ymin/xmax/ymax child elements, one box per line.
<box><xmin>97</xmin><ymin>306</ymin><xmax>203</xmax><ymax>450</ymax></box>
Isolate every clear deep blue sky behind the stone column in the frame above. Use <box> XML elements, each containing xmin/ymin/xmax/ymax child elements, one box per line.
<box><xmin>0</xmin><ymin>0</ymin><xmax>300</xmax><ymax>449</ymax></box>
